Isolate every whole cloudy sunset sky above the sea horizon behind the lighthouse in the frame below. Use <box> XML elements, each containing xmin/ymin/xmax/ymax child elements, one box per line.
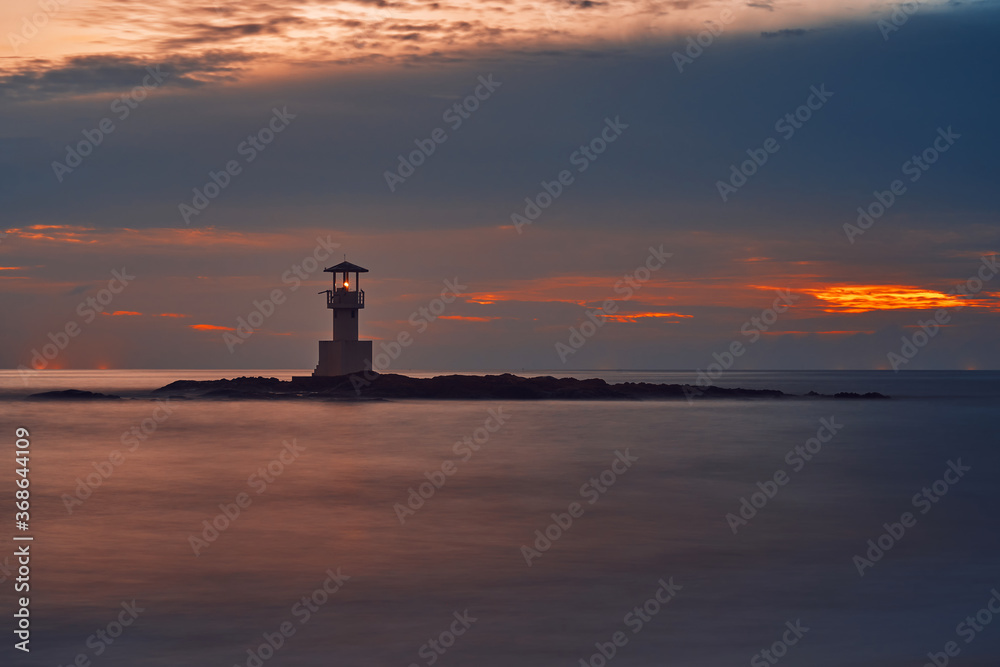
<box><xmin>0</xmin><ymin>0</ymin><xmax>1000</xmax><ymax>371</ymax></box>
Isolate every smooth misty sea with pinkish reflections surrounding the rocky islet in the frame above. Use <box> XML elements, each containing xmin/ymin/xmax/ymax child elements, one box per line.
<box><xmin>0</xmin><ymin>369</ymin><xmax>1000</xmax><ymax>667</ymax></box>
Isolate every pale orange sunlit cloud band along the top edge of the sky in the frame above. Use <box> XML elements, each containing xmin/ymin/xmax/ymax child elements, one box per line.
<box><xmin>4</xmin><ymin>0</ymin><xmax>916</xmax><ymax>74</ymax></box>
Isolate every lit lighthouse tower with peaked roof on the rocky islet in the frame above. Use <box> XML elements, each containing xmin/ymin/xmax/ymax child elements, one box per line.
<box><xmin>313</xmin><ymin>260</ymin><xmax>372</xmax><ymax>377</ymax></box>
